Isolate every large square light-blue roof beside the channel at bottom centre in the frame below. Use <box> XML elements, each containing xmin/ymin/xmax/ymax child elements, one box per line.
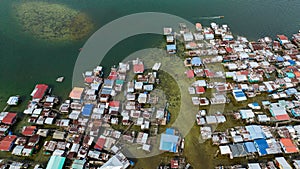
<box><xmin>159</xmin><ymin>133</ymin><xmax>179</xmax><ymax>153</ymax></box>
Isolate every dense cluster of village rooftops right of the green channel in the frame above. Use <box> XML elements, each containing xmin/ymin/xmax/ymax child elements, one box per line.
<box><xmin>164</xmin><ymin>23</ymin><xmax>300</xmax><ymax>168</ymax></box>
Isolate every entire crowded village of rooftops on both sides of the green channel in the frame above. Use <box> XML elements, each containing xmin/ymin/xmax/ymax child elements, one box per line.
<box><xmin>0</xmin><ymin>23</ymin><xmax>300</xmax><ymax>169</ymax></box>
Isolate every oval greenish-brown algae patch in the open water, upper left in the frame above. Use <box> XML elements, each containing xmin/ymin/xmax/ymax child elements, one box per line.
<box><xmin>15</xmin><ymin>2</ymin><xmax>93</xmax><ymax>40</ymax></box>
